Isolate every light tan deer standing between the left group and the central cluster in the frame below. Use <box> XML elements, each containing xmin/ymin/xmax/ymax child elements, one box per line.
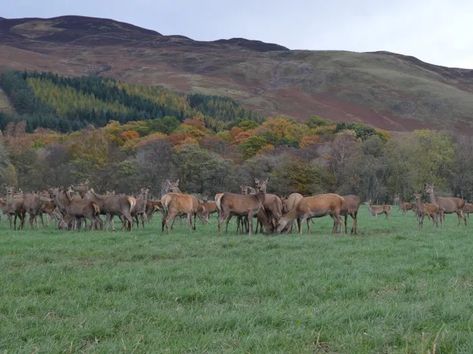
<box><xmin>161</xmin><ymin>193</ymin><xmax>199</xmax><ymax>231</ymax></box>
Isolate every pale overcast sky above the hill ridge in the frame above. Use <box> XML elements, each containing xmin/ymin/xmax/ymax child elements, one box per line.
<box><xmin>0</xmin><ymin>0</ymin><xmax>473</xmax><ymax>69</ymax></box>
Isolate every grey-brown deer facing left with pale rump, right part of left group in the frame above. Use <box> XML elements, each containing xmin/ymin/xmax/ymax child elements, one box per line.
<box><xmin>85</xmin><ymin>188</ymin><xmax>136</xmax><ymax>231</ymax></box>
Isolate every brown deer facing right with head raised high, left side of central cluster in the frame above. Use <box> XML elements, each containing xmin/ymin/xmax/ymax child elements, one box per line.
<box><xmin>216</xmin><ymin>180</ymin><xmax>267</xmax><ymax>235</ymax></box>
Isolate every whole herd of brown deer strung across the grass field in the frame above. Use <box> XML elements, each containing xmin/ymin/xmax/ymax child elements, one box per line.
<box><xmin>0</xmin><ymin>179</ymin><xmax>473</xmax><ymax>235</ymax></box>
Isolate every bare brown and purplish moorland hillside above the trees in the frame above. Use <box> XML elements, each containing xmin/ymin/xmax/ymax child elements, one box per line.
<box><xmin>0</xmin><ymin>16</ymin><xmax>473</xmax><ymax>134</ymax></box>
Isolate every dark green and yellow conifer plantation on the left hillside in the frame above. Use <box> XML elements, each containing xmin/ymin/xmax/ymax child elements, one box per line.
<box><xmin>0</xmin><ymin>71</ymin><xmax>261</xmax><ymax>132</ymax></box>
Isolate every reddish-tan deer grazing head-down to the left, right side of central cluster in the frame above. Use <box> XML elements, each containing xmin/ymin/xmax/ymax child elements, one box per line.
<box><xmin>277</xmin><ymin>193</ymin><xmax>343</xmax><ymax>234</ymax></box>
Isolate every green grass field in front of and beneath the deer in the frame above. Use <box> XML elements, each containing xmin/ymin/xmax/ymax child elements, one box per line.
<box><xmin>0</xmin><ymin>207</ymin><xmax>473</xmax><ymax>353</ymax></box>
